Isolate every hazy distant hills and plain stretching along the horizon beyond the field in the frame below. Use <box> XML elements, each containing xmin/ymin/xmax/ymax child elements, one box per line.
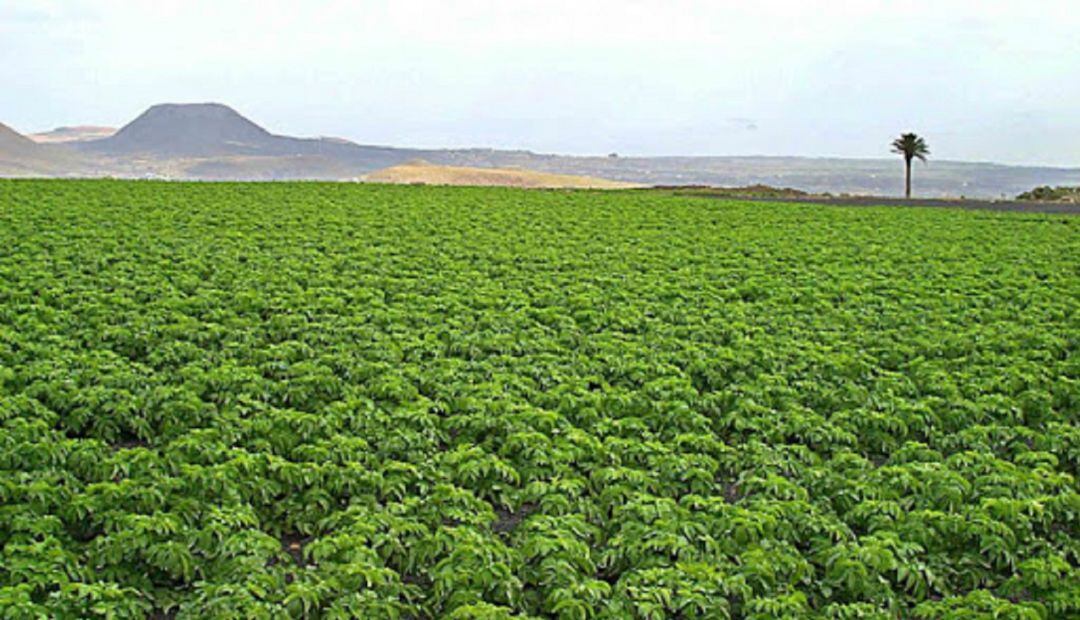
<box><xmin>0</xmin><ymin>104</ymin><xmax>1080</xmax><ymax>198</ymax></box>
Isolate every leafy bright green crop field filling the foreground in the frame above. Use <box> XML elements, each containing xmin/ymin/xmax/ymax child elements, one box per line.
<box><xmin>0</xmin><ymin>180</ymin><xmax>1080</xmax><ymax>620</ymax></box>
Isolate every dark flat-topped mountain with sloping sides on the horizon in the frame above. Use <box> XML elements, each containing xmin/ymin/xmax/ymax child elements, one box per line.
<box><xmin>73</xmin><ymin>104</ymin><xmax>416</xmax><ymax>173</ymax></box>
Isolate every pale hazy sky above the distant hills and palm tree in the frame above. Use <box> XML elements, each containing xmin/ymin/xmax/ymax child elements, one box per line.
<box><xmin>0</xmin><ymin>0</ymin><xmax>1080</xmax><ymax>165</ymax></box>
